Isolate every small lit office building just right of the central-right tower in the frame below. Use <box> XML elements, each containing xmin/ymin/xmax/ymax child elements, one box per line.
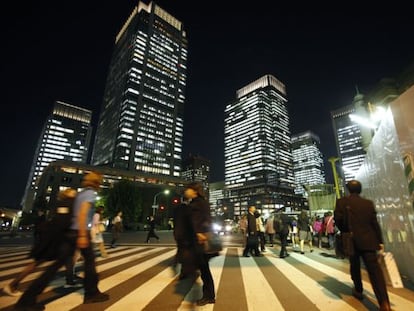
<box><xmin>292</xmin><ymin>131</ymin><xmax>325</xmax><ymax>195</ymax></box>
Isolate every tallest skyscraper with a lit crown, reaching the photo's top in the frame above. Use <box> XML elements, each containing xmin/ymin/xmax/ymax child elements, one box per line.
<box><xmin>92</xmin><ymin>2</ymin><xmax>187</xmax><ymax>177</ymax></box>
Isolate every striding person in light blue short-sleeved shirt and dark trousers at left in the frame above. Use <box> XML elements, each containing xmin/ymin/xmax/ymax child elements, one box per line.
<box><xmin>14</xmin><ymin>172</ymin><xmax>109</xmax><ymax>311</ymax></box>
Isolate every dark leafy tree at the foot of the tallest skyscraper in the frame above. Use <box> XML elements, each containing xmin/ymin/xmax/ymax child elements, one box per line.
<box><xmin>105</xmin><ymin>179</ymin><xmax>143</xmax><ymax>228</ymax></box>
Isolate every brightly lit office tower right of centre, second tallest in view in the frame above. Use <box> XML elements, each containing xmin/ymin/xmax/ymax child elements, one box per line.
<box><xmin>224</xmin><ymin>75</ymin><xmax>294</xmax><ymax>216</ymax></box>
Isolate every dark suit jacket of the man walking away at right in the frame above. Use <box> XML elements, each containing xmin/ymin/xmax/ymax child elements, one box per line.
<box><xmin>334</xmin><ymin>194</ymin><xmax>383</xmax><ymax>251</ymax></box>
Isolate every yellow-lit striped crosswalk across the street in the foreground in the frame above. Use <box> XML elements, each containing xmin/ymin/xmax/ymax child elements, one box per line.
<box><xmin>0</xmin><ymin>245</ymin><xmax>414</xmax><ymax>311</ymax></box>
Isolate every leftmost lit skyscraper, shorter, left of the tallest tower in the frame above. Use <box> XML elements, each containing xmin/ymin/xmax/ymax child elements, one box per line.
<box><xmin>22</xmin><ymin>101</ymin><xmax>92</xmax><ymax>210</ymax></box>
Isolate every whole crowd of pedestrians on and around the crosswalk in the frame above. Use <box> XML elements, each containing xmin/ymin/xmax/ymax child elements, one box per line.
<box><xmin>3</xmin><ymin>179</ymin><xmax>391</xmax><ymax>311</ymax></box>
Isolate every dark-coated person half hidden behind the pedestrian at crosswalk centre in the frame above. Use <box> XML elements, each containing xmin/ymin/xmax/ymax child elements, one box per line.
<box><xmin>173</xmin><ymin>199</ymin><xmax>197</xmax><ymax>279</ymax></box>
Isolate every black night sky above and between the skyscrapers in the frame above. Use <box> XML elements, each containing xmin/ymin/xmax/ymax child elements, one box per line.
<box><xmin>0</xmin><ymin>0</ymin><xmax>414</xmax><ymax>206</ymax></box>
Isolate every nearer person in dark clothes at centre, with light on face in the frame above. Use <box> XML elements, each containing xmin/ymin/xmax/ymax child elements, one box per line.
<box><xmin>184</xmin><ymin>182</ymin><xmax>218</xmax><ymax>306</ymax></box>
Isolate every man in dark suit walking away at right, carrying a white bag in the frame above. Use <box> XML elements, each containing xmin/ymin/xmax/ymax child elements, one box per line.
<box><xmin>334</xmin><ymin>180</ymin><xmax>391</xmax><ymax>311</ymax></box>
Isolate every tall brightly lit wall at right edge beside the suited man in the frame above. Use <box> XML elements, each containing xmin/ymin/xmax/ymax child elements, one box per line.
<box><xmin>356</xmin><ymin>87</ymin><xmax>414</xmax><ymax>280</ymax></box>
